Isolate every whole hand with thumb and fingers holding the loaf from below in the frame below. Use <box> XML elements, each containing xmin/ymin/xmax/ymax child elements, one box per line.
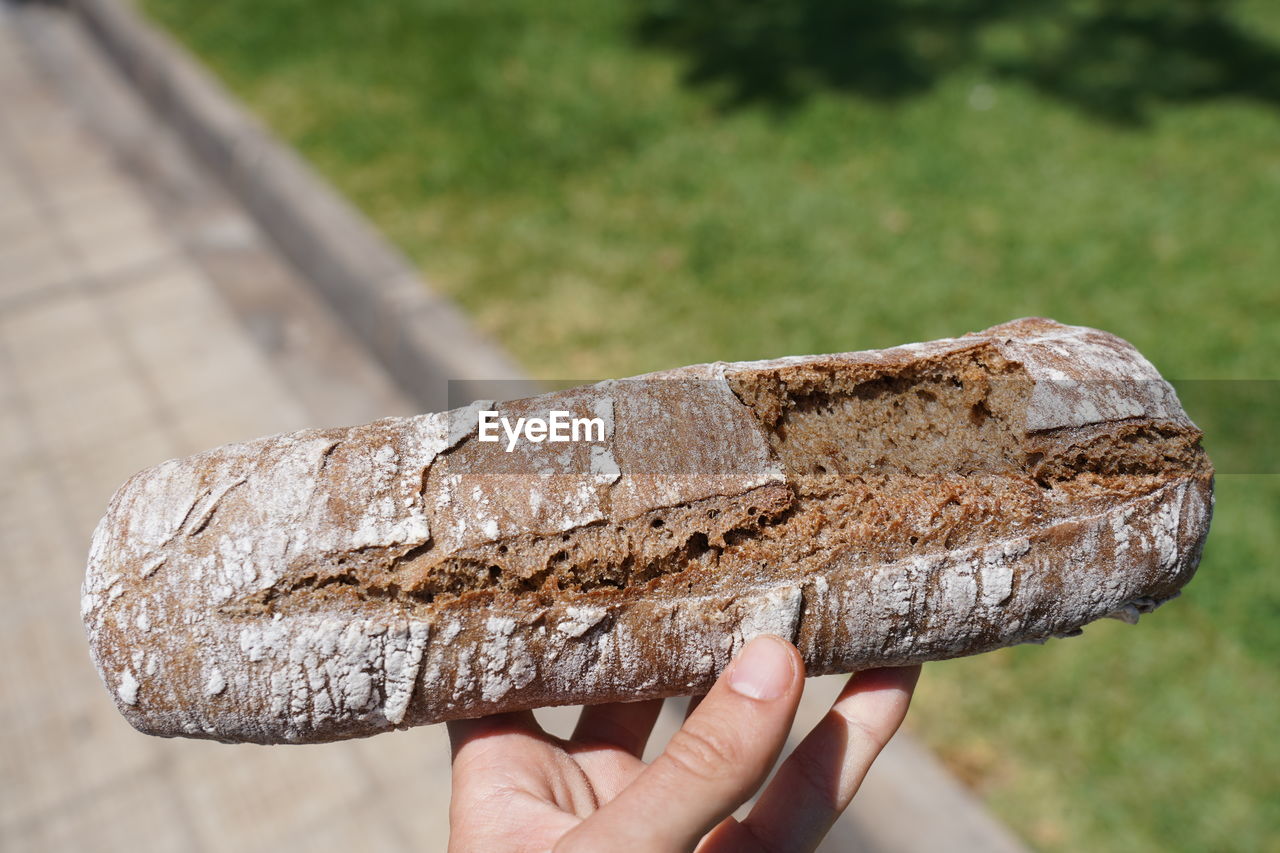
<box><xmin>448</xmin><ymin>635</ymin><xmax>920</xmax><ymax>853</ymax></box>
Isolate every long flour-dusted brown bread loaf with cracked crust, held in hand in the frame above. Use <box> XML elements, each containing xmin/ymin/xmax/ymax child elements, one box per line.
<box><xmin>82</xmin><ymin>318</ymin><xmax>1213</xmax><ymax>743</ymax></box>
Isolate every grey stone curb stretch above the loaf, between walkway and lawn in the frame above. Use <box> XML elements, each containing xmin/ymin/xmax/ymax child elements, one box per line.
<box><xmin>65</xmin><ymin>0</ymin><xmax>522</xmax><ymax>410</ymax></box>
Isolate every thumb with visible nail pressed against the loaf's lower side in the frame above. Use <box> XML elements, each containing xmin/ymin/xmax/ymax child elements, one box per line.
<box><xmin>556</xmin><ymin>635</ymin><xmax>804</xmax><ymax>853</ymax></box>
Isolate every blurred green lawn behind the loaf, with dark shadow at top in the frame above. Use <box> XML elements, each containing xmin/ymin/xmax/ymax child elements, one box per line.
<box><xmin>145</xmin><ymin>0</ymin><xmax>1280</xmax><ymax>850</ymax></box>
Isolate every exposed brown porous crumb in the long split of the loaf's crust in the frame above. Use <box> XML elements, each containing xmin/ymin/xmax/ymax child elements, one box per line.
<box><xmin>236</xmin><ymin>348</ymin><xmax>1207</xmax><ymax>612</ymax></box>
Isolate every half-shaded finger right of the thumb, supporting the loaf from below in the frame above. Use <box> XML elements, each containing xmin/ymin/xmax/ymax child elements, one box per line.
<box><xmin>742</xmin><ymin>666</ymin><xmax>920</xmax><ymax>852</ymax></box>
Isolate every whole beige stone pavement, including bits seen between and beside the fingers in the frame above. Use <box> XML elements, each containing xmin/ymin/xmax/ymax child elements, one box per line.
<box><xmin>0</xmin><ymin>0</ymin><xmax>1016</xmax><ymax>850</ymax></box>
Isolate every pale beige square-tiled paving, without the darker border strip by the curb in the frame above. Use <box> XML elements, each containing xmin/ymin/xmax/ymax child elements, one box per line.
<box><xmin>0</xmin><ymin>8</ymin><xmax>460</xmax><ymax>850</ymax></box>
